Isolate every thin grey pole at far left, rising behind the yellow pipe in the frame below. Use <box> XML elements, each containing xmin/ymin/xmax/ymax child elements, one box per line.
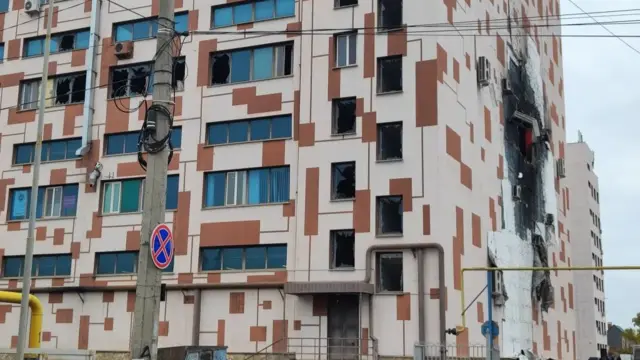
<box><xmin>16</xmin><ymin>0</ymin><xmax>54</xmax><ymax>360</ymax></box>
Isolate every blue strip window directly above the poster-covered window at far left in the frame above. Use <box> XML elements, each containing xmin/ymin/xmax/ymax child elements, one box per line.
<box><xmin>13</xmin><ymin>138</ymin><xmax>82</xmax><ymax>165</ymax></box>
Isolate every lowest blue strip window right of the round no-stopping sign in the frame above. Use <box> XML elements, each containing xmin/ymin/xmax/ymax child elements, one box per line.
<box><xmin>200</xmin><ymin>245</ymin><xmax>287</xmax><ymax>271</ymax></box>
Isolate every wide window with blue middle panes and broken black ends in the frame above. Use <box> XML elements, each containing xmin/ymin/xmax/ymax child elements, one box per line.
<box><xmin>211</xmin><ymin>43</ymin><xmax>293</xmax><ymax>85</ymax></box>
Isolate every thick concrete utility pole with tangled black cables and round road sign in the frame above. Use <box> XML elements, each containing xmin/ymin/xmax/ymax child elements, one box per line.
<box><xmin>131</xmin><ymin>0</ymin><xmax>175</xmax><ymax>360</ymax></box>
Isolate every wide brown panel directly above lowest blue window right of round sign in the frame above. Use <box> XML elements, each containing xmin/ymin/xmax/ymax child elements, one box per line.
<box><xmin>200</xmin><ymin>220</ymin><xmax>260</xmax><ymax>246</ymax></box>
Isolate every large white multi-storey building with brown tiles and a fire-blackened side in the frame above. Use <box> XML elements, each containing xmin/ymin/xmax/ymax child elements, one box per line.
<box><xmin>0</xmin><ymin>0</ymin><xmax>577</xmax><ymax>359</ymax></box>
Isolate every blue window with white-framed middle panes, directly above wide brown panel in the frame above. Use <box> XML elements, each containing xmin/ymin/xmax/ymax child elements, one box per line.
<box><xmin>204</xmin><ymin>166</ymin><xmax>290</xmax><ymax>207</ymax></box>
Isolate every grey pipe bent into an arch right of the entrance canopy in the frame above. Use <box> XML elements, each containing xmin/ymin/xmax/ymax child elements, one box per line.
<box><xmin>363</xmin><ymin>243</ymin><xmax>447</xmax><ymax>360</ymax></box>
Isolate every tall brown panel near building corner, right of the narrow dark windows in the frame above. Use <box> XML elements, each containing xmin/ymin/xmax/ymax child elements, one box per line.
<box><xmin>415</xmin><ymin>60</ymin><xmax>439</xmax><ymax>127</ymax></box>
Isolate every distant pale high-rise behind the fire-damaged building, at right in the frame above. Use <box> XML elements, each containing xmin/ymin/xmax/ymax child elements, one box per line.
<box><xmin>565</xmin><ymin>134</ymin><xmax>608</xmax><ymax>358</ymax></box>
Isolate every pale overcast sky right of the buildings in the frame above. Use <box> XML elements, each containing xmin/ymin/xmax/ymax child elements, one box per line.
<box><xmin>561</xmin><ymin>0</ymin><xmax>640</xmax><ymax>327</ymax></box>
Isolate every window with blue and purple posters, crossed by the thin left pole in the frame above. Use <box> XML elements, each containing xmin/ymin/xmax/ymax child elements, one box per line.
<box><xmin>9</xmin><ymin>184</ymin><xmax>78</xmax><ymax>220</ymax></box>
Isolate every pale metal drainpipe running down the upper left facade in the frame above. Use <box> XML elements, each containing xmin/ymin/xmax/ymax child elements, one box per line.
<box><xmin>76</xmin><ymin>0</ymin><xmax>102</xmax><ymax>156</ymax></box>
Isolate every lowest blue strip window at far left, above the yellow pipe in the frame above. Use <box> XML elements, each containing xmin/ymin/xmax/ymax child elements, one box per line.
<box><xmin>2</xmin><ymin>254</ymin><xmax>71</xmax><ymax>278</ymax></box>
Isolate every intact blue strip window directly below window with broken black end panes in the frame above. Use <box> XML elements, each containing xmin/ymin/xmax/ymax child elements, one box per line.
<box><xmin>207</xmin><ymin>115</ymin><xmax>291</xmax><ymax>145</ymax></box>
